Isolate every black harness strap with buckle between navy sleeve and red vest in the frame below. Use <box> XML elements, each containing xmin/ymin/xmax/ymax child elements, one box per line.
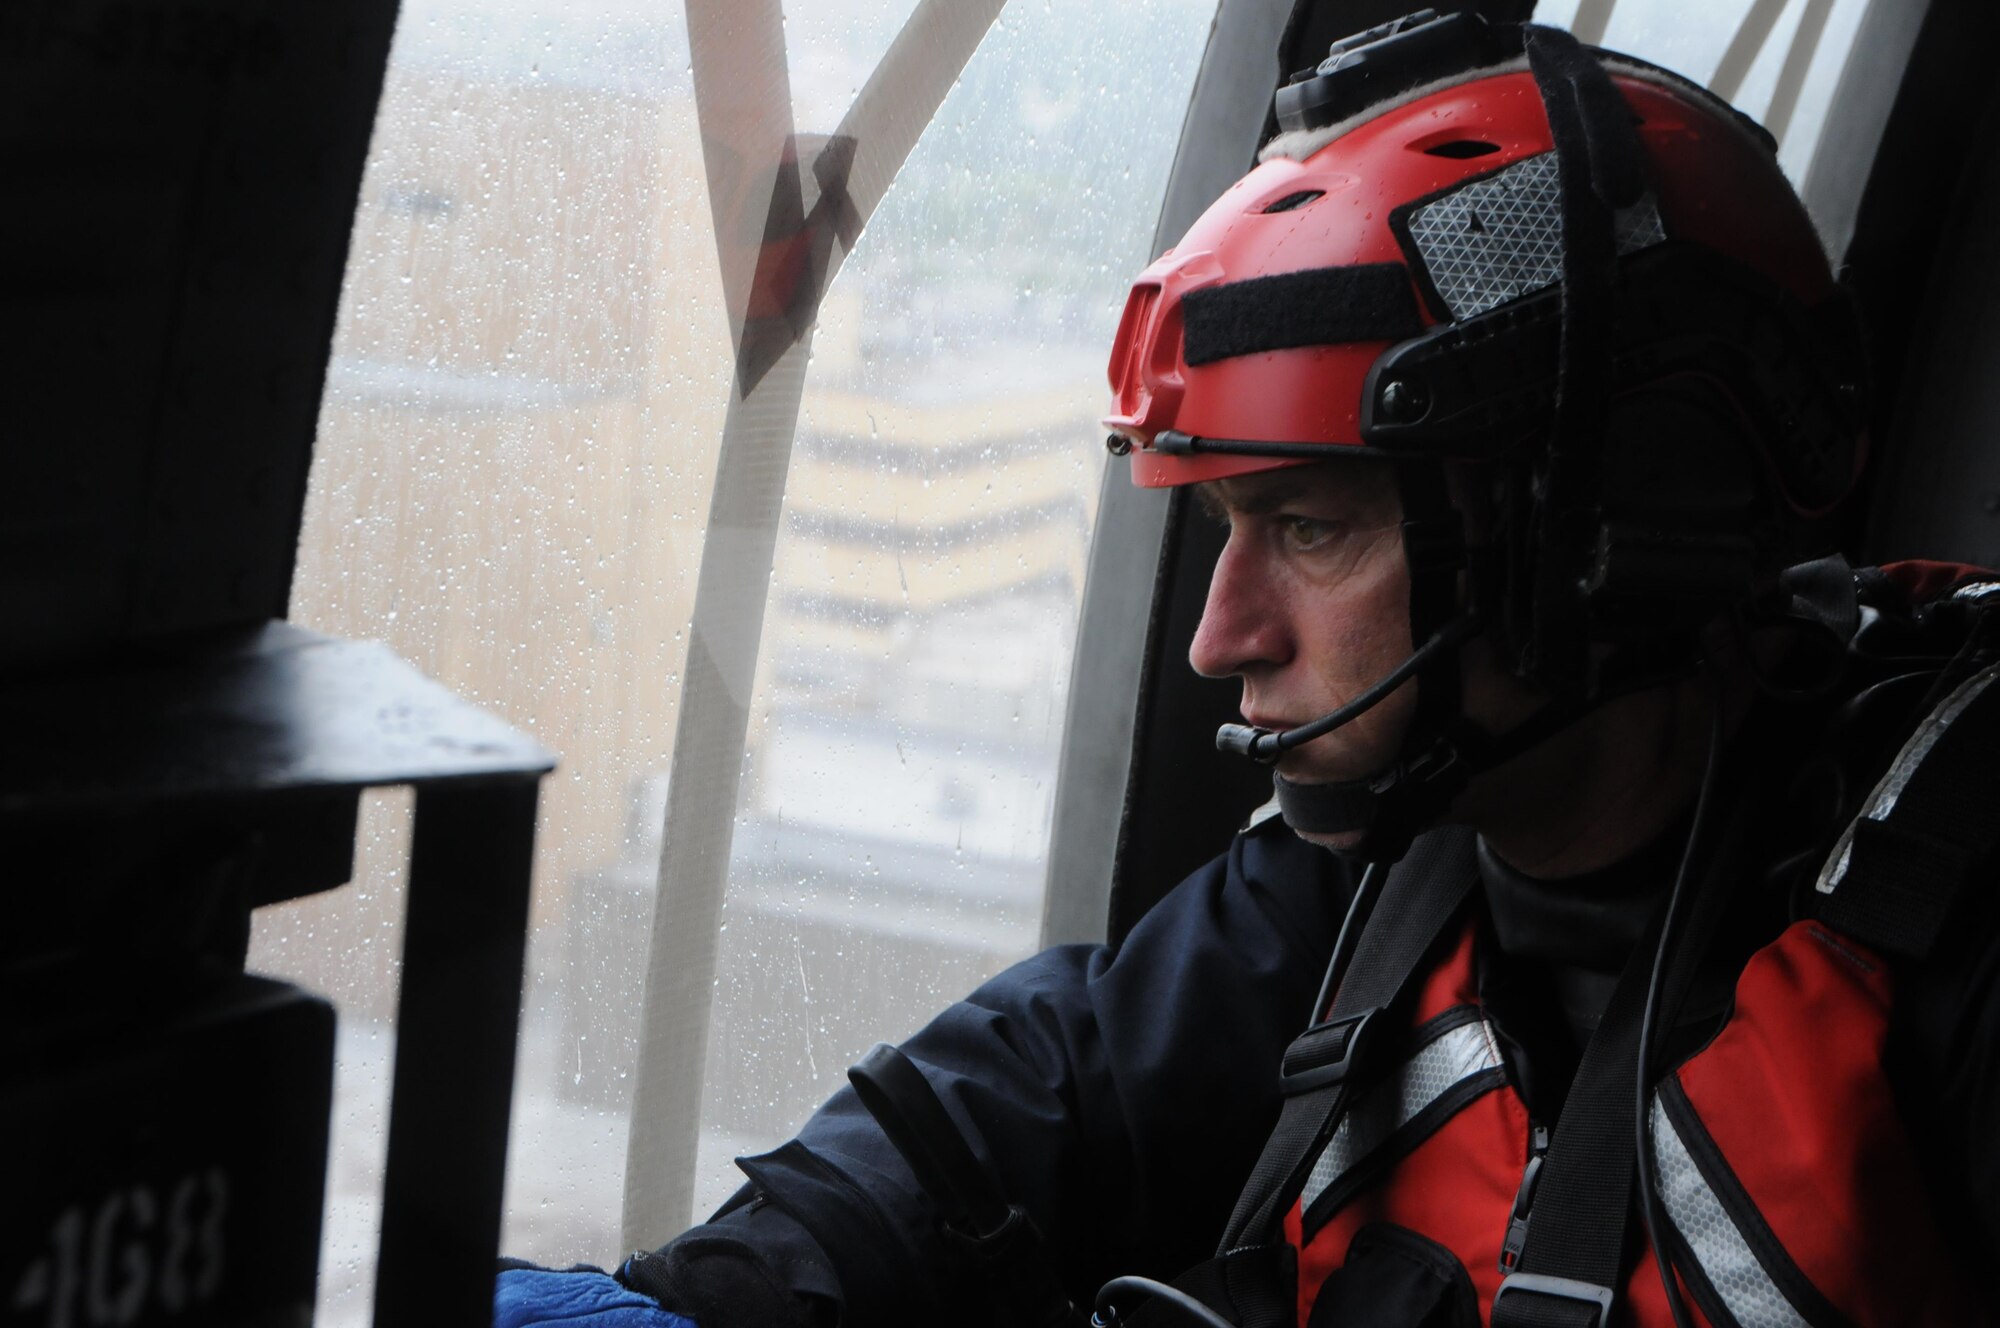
<box><xmin>1218</xmin><ymin>826</ymin><xmax>1478</xmax><ymax>1254</ymax></box>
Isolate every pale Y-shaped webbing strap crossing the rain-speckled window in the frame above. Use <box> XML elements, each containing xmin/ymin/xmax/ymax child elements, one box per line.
<box><xmin>622</xmin><ymin>0</ymin><xmax>1002</xmax><ymax>1250</ymax></box>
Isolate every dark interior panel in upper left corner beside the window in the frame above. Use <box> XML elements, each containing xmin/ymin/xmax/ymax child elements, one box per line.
<box><xmin>0</xmin><ymin>0</ymin><xmax>396</xmax><ymax>672</ymax></box>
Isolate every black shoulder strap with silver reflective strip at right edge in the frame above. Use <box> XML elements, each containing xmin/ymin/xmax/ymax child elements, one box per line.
<box><xmin>1818</xmin><ymin>664</ymin><xmax>2000</xmax><ymax>960</ymax></box>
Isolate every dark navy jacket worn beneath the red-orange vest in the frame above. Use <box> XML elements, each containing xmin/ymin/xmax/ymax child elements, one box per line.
<box><xmin>640</xmin><ymin>804</ymin><xmax>2000</xmax><ymax>1328</ymax></box>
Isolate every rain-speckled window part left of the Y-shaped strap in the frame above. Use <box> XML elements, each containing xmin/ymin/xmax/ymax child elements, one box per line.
<box><xmin>250</xmin><ymin>0</ymin><xmax>730</xmax><ymax>1328</ymax></box>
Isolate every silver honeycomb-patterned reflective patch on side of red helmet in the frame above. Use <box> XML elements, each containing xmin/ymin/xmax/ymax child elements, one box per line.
<box><xmin>1404</xmin><ymin>152</ymin><xmax>1666</xmax><ymax>320</ymax></box>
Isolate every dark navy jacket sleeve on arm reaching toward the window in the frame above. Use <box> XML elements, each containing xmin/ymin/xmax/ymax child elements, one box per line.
<box><xmin>662</xmin><ymin>820</ymin><xmax>1352</xmax><ymax>1328</ymax></box>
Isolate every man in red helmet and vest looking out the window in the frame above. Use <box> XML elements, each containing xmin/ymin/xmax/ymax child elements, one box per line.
<box><xmin>500</xmin><ymin>14</ymin><xmax>2000</xmax><ymax>1328</ymax></box>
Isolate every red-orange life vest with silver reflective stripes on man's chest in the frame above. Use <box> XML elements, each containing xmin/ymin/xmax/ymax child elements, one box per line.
<box><xmin>1284</xmin><ymin>922</ymin><xmax>1982</xmax><ymax>1328</ymax></box>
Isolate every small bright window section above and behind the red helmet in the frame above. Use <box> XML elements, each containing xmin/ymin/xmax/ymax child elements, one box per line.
<box><xmin>1534</xmin><ymin>0</ymin><xmax>1880</xmax><ymax>186</ymax></box>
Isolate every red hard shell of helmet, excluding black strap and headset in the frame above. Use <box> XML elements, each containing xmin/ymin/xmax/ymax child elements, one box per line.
<box><xmin>1104</xmin><ymin>16</ymin><xmax>1860</xmax><ymax>512</ymax></box>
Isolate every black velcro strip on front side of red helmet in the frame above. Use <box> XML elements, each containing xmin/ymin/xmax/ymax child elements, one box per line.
<box><xmin>1180</xmin><ymin>262</ymin><xmax>1424</xmax><ymax>364</ymax></box>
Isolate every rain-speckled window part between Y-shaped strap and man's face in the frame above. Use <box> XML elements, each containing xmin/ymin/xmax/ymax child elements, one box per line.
<box><xmin>694</xmin><ymin>0</ymin><xmax>1214</xmax><ymax>1212</ymax></box>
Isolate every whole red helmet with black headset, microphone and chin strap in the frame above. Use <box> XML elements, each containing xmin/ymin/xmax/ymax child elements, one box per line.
<box><xmin>1104</xmin><ymin>10</ymin><xmax>1862</xmax><ymax>854</ymax></box>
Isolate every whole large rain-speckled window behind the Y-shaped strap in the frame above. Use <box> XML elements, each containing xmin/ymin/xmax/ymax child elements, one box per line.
<box><xmin>250</xmin><ymin>0</ymin><xmax>1214</xmax><ymax>1326</ymax></box>
